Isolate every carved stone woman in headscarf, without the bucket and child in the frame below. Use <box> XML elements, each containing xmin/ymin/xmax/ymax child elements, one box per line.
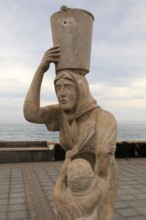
<box><xmin>24</xmin><ymin>47</ymin><xmax>118</xmax><ymax>220</ymax></box>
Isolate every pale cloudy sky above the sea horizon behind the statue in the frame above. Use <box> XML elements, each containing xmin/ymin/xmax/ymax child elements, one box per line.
<box><xmin>0</xmin><ymin>0</ymin><xmax>146</xmax><ymax>123</ymax></box>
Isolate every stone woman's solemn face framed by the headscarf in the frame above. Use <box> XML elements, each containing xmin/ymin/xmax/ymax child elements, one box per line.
<box><xmin>55</xmin><ymin>78</ymin><xmax>78</xmax><ymax>113</ymax></box>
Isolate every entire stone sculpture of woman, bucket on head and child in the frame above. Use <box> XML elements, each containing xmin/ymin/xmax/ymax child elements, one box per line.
<box><xmin>24</xmin><ymin>7</ymin><xmax>118</xmax><ymax>220</ymax></box>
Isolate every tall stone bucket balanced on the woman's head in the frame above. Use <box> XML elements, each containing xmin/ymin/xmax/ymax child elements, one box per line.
<box><xmin>51</xmin><ymin>6</ymin><xmax>94</xmax><ymax>75</ymax></box>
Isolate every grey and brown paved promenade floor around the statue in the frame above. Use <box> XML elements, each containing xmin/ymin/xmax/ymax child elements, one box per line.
<box><xmin>0</xmin><ymin>158</ymin><xmax>146</xmax><ymax>220</ymax></box>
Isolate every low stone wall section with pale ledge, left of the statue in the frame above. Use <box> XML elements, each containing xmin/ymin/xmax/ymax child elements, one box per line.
<box><xmin>0</xmin><ymin>141</ymin><xmax>56</xmax><ymax>163</ymax></box>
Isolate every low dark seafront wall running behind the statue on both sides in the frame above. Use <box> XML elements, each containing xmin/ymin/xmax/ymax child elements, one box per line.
<box><xmin>0</xmin><ymin>141</ymin><xmax>146</xmax><ymax>163</ymax></box>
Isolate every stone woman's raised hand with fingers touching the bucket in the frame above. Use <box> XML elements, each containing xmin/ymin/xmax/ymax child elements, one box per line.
<box><xmin>39</xmin><ymin>46</ymin><xmax>61</xmax><ymax>72</ymax></box>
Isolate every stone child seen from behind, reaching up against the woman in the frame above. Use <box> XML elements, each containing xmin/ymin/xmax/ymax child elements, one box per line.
<box><xmin>54</xmin><ymin>156</ymin><xmax>103</xmax><ymax>220</ymax></box>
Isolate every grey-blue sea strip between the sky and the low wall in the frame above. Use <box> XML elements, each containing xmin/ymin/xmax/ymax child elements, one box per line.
<box><xmin>0</xmin><ymin>123</ymin><xmax>146</xmax><ymax>142</ymax></box>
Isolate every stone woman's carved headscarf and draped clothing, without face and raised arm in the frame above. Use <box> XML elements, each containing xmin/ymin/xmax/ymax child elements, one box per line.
<box><xmin>46</xmin><ymin>71</ymin><xmax>118</xmax><ymax>220</ymax></box>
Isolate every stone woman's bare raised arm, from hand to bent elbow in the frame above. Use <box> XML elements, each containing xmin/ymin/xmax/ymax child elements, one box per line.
<box><xmin>24</xmin><ymin>46</ymin><xmax>60</xmax><ymax>123</ymax></box>
